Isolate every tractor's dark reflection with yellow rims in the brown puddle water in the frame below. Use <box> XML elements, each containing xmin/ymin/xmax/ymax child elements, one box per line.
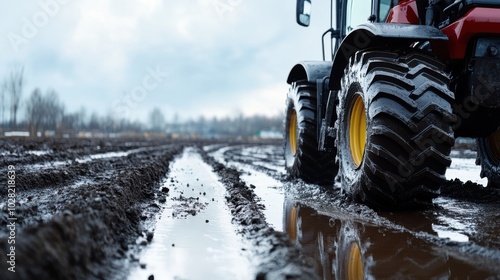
<box><xmin>283</xmin><ymin>198</ymin><xmax>491</xmax><ymax>279</ymax></box>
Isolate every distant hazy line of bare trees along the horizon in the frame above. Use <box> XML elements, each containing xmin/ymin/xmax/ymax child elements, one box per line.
<box><xmin>0</xmin><ymin>67</ymin><xmax>283</xmax><ymax>138</ymax></box>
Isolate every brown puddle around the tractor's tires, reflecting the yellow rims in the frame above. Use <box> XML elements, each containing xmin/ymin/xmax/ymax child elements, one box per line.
<box><xmin>204</xmin><ymin>146</ymin><xmax>500</xmax><ymax>279</ymax></box>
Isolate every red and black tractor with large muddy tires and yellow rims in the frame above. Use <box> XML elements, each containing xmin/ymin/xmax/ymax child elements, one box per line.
<box><xmin>284</xmin><ymin>0</ymin><xmax>500</xmax><ymax>209</ymax></box>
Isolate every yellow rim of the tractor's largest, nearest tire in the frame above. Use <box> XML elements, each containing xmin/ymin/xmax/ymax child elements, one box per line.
<box><xmin>349</xmin><ymin>93</ymin><xmax>366</xmax><ymax>168</ymax></box>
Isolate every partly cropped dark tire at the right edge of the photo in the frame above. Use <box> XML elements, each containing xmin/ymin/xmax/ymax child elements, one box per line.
<box><xmin>476</xmin><ymin>129</ymin><xmax>500</xmax><ymax>188</ymax></box>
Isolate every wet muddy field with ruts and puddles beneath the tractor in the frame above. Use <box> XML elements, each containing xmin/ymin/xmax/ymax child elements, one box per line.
<box><xmin>0</xmin><ymin>139</ymin><xmax>500</xmax><ymax>279</ymax></box>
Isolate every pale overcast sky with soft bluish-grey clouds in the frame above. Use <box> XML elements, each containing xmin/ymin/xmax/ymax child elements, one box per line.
<box><xmin>0</xmin><ymin>0</ymin><xmax>329</xmax><ymax>121</ymax></box>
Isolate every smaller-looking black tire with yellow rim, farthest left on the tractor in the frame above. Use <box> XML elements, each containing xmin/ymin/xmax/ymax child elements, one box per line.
<box><xmin>284</xmin><ymin>82</ymin><xmax>338</xmax><ymax>186</ymax></box>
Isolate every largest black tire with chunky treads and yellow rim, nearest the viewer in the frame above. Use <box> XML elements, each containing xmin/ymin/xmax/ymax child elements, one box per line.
<box><xmin>335</xmin><ymin>50</ymin><xmax>456</xmax><ymax>209</ymax></box>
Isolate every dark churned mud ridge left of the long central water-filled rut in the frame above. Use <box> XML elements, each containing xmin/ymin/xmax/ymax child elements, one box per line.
<box><xmin>0</xmin><ymin>140</ymin><xmax>183</xmax><ymax>279</ymax></box>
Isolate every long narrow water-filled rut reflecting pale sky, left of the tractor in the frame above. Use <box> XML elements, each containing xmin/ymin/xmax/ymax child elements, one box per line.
<box><xmin>129</xmin><ymin>149</ymin><xmax>255</xmax><ymax>280</ymax></box>
